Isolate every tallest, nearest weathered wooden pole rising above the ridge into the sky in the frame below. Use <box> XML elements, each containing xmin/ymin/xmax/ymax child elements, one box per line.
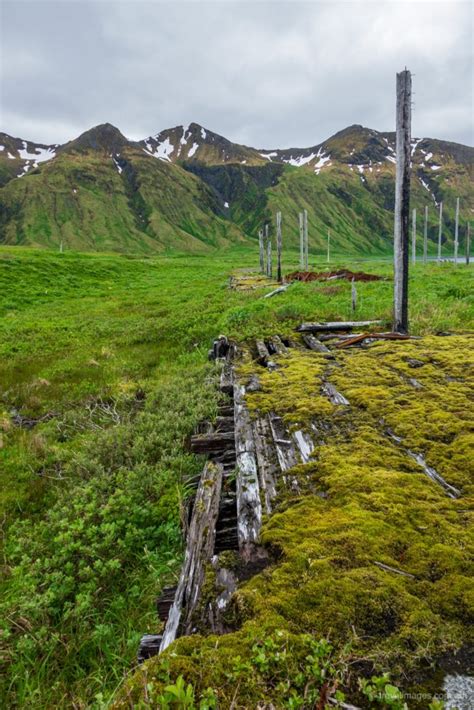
<box><xmin>393</xmin><ymin>69</ymin><xmax>411</xmax><ymax>333</ymax></box>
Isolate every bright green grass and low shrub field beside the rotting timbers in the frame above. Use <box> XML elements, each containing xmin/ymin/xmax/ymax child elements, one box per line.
<box><xmin>0</xmin><ymin>247</ymin><xmax>474</xmax><ymax>708</ymax></box>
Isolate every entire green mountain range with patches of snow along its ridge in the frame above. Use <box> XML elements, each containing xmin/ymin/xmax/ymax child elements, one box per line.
<box><xmin>0</xmin><ymin>123</ymin><xmax>474</xmax><ymax>254</ymax></box>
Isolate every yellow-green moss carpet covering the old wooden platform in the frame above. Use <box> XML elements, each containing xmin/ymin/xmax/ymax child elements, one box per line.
<box><xmin>117</xmin><ymin>336</ymin><xmax>474</xmax><ymax>708</ymax></box>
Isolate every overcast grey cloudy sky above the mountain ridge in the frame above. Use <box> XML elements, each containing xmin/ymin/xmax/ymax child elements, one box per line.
<box><xmin>0</xmin><ymin>0</ymin><xmax>474</xmax><ymax>148</ymax></box>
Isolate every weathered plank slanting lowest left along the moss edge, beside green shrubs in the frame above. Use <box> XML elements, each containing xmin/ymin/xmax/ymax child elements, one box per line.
<box><xmin>160</xmin><ymin>462</ymin><xmax>223</xmax><ymax>652</ymax></box>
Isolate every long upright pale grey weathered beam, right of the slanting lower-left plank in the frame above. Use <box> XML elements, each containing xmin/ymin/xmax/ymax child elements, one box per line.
<box><xmin>234</xmin><ymin>382</ymin><xmax>262</xmax><ymax>558</ymax></box>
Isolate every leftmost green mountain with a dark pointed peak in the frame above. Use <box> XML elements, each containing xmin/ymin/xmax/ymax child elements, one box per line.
<box><xmin>0</xmin><ymin>124</ymin><xmax>242</xmax><ymax>252</ymax></box>
